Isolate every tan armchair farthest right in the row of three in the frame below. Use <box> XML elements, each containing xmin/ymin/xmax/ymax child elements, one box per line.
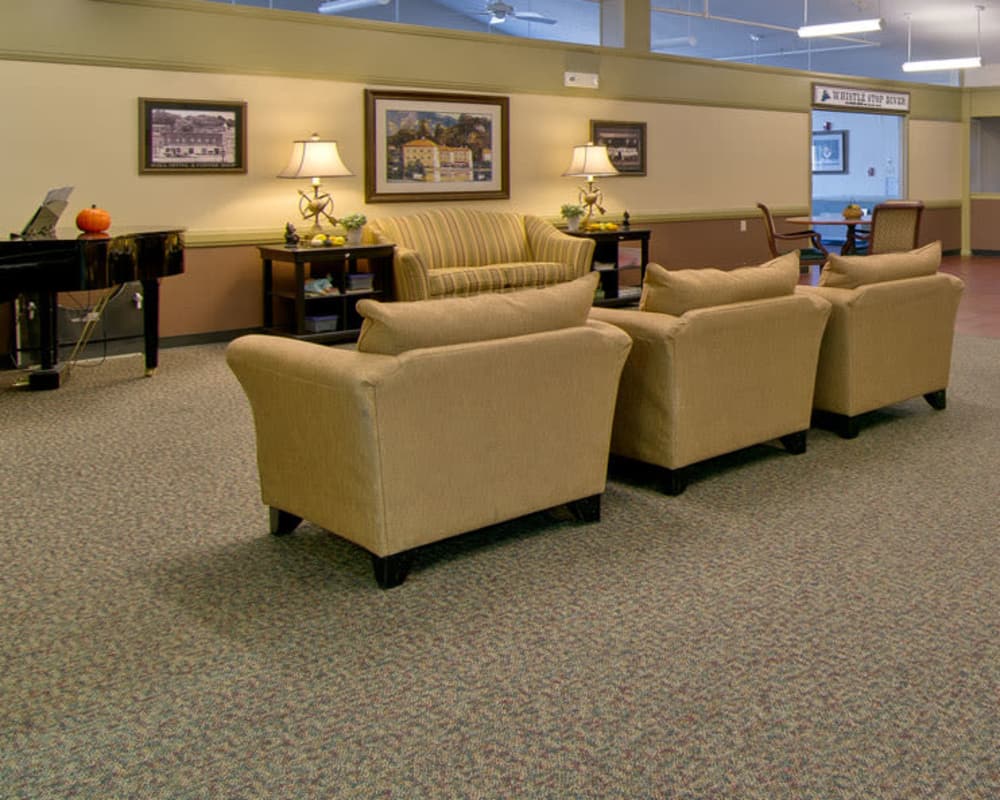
<box><xmin>797</xmin><ymin>242</ymin><xmax>964</xmax><ymax>438</ymax></box>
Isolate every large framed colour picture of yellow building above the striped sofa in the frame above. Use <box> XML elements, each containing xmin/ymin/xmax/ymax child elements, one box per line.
<box><xmin>365</xmin><ymin>89</ymin><xmax>510</xmax><ymax>203</ymax></box>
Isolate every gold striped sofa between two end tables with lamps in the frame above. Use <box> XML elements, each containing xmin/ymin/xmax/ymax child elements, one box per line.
<box><xmin>365</xmin><ymin>208</ymin><xmax>594</xmax><ymax>300</ymax></box>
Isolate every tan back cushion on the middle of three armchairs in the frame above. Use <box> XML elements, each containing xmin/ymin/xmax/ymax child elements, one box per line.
<box><xmin>639</xmin><ymin>250</ymin><xmax>799</xmax><ymax>317</ymax></box>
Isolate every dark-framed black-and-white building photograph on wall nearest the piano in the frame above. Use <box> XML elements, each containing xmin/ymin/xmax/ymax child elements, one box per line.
<box><xmin>139</xmin><ymin>97</ymin><xmax>247</xmax><ymax>174</ymax></box>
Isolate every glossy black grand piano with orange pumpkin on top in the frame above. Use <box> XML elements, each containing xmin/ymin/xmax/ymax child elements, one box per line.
<box><xmin>0</xmin><ymin>228</ymin><xmax>184</xmax><ymax>389</ymax></box>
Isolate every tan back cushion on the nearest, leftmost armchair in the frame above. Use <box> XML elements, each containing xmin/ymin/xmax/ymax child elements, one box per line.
<box><xmin>357</xmin><ymin>272</ymin><xmax>599</xmax><ymax>355</ymax></box>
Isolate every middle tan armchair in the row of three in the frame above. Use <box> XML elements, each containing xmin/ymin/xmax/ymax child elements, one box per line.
<box><xmin>591</xmin><ymin>252</ymin><xmax>830</xmax><ymax>494</ymax></box>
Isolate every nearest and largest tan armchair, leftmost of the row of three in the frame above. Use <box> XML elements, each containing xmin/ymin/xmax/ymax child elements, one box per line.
<box><xmin>226</xmin><ymin>273</ymin><xmax>630</xmax><ymax>588</ymax></box>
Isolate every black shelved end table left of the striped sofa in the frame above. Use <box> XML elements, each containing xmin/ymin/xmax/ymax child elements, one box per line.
<box><xmin>258</xmin><ymin>244</ymin><xmax>395</xmax><ymax>343</ymax></box>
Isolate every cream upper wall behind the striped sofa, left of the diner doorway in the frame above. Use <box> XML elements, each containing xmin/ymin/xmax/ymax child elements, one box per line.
<box><xmin>0</xmin><ymin>61</ymin><xmax>809</xmax><ymax>240</ymax></box>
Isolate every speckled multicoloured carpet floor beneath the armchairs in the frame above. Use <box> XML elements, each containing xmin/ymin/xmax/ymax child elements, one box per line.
<box><xmin>0</xmin><ymin>337</ymin><xmax>1000</xmax><ymax>800</ymax></box>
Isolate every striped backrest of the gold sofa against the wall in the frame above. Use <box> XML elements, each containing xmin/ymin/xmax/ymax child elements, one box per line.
<box><xmin>371</xmin><ymin>208</ymin><xmax>530</xmax><ymax>272</ymax></box>
